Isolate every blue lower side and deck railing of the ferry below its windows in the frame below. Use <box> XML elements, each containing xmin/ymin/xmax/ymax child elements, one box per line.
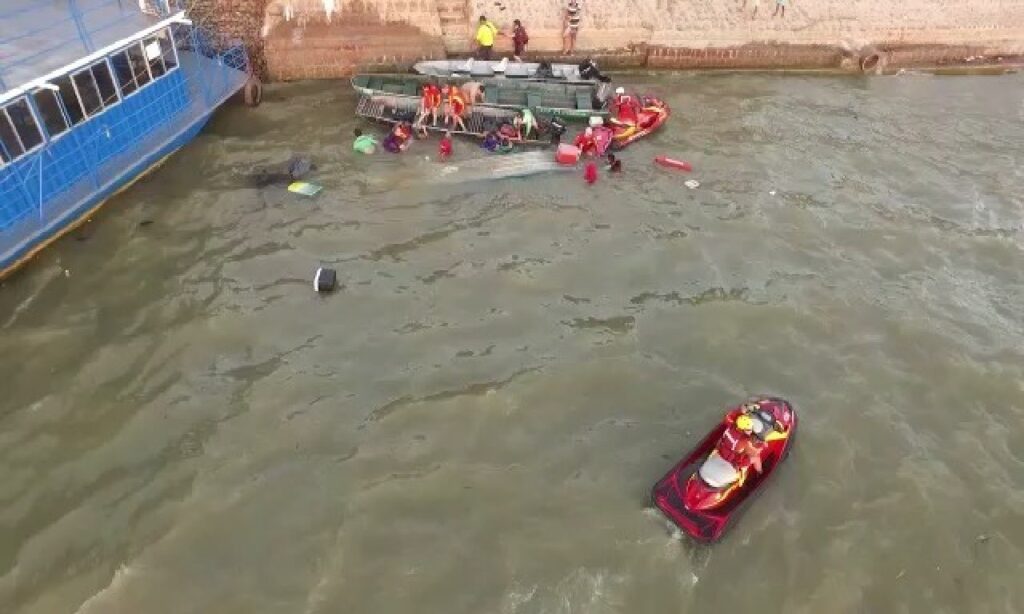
<box><xmin>0</xmin><ymin>25</ymin><xmax>249</xmax><ymax>244</ymax></box>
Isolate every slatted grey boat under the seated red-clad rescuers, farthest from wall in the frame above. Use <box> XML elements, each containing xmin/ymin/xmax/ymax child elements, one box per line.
<box><xmin>355</xmin><ymin>94</ymin><xmax>552</xmax><ymax>145</ymax></box>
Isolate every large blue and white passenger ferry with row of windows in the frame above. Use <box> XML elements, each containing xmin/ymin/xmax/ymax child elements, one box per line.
<box><xmin>0</xmin><ymin>0</ymin><xmax>250</xmax><ymax>277</ymax></box>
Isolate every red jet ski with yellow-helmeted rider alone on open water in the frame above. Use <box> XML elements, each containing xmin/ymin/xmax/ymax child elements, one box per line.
<box><xmin>651</xmin><ymin>398</ymin><xmax>797</xmax><ymax>541</ymax></box>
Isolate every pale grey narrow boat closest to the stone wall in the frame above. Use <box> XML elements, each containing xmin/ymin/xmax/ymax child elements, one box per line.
<box><xmin>413</xmin><ymin>57</ymin><xmax>609</xmax><ymax>82</ymax></box>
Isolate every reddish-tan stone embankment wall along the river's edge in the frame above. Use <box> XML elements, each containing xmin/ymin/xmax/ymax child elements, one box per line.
<box><xmin>194</xmin><ymin>0</ymin><xmax>1024</xmax><ymax>79</ymax></box>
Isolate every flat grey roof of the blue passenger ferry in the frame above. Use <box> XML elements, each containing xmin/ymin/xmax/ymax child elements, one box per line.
<box><xmin>0</xmin><ymin>0</ymin><xmax>165</xmax><ymax>102</ymax></box>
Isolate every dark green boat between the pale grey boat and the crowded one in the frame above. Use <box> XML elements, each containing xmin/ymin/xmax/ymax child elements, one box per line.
<box><xmin>352</xmin><ymin>74</ymin><xmax>611</xmax><ymax>120</ymax></box>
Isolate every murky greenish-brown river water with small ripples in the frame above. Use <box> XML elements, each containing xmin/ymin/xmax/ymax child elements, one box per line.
<box><xmin>0</xmin><ymin>74</ymin><xmax>1024</xmax><ymax>614</ymax></box>
